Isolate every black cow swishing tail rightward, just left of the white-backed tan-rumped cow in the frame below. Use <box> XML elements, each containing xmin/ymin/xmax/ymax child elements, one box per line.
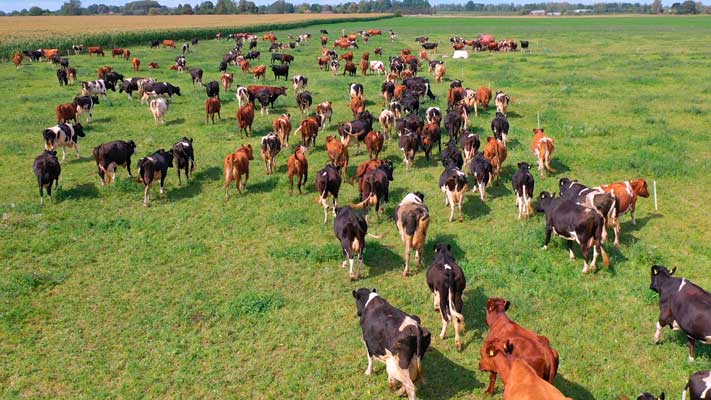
<box><xmin>333</xmin><ymin>207</ymin><xmax>368</xmax><ymax>281</ymax></box>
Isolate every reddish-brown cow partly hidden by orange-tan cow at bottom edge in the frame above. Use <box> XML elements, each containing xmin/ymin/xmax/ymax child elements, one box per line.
<box><xmin>479</xmin><ymin>297</ymin><xmax>558</xmax><ymax>399</ymax></box>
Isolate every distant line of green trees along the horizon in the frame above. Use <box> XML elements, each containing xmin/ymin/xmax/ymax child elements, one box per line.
<box><xmin>0</xmin><ymin>0</ymin><xmax>711</xmax><ymax>16</ymax></box>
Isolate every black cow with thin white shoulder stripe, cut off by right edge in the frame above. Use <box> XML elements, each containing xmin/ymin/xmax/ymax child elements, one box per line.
<box><xmin>649</xmin><ymin>265</ymin><xmax>711</xmax><ymax>361</ymax></box>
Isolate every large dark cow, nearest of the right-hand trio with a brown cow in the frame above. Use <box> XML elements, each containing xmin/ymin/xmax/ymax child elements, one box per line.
<box><xmin>536</xmin><ymin>192</ymin><xmax>610</xmax><ymax>274</ymax></box>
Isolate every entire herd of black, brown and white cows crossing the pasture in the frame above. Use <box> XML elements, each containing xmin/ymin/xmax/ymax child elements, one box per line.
<box><xmin>14</xmin><ymin>24</ymin><xmax>711</xmax><ymax>400</ymax></box>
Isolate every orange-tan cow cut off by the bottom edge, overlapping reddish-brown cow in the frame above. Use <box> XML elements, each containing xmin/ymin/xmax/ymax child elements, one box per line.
<box><xmin>482</xmin><ymin>339</ymin><xmax>572</xmax><ymax>400</ymax></box>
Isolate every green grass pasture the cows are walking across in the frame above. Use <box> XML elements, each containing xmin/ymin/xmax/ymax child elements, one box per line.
<box><xmin>0</xmin><ymin>17</ymin><xmax>711</xmax><ymax>399</ymax></box>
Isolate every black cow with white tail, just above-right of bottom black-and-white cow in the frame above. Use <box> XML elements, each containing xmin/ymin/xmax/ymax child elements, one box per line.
<box><xmin>427</xmin><ymin>243</ymin><xmax>467</xmax><ymax>351</ymax></box>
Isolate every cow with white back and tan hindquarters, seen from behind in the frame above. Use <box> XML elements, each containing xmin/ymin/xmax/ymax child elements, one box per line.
<box><xmin>395</xmin><ymin>192</ymin><xmax>430</xmax><ymax>277</ymax></box>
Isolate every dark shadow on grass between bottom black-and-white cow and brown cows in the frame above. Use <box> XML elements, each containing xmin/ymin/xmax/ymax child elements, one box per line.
<box><xmin>417</xmin><ymin>346</ymin><xmax>484</xmax><ymax>400</ymax></box>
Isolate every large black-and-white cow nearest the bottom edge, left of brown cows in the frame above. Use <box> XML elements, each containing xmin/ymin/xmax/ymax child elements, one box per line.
<box><xmin>353</xmin><ymin>288</ymin><xmax>432</xmax><ymax>400</ymax></box>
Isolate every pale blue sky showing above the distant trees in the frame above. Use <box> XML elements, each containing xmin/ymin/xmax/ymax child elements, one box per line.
<box><xmin>0</xmin><ymin>0</ymin><xmax>680</xmax><ymax>12</ymax></box>
